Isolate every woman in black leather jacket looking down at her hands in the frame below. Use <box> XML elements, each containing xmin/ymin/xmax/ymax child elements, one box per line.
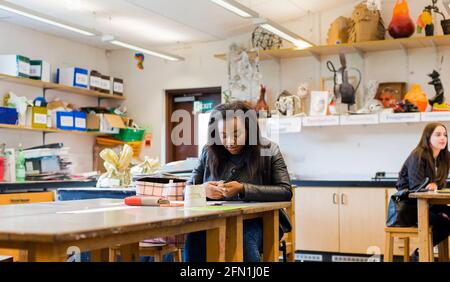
<box><xmin>184</xmin><ymin>101</ymin><xmax>292</xmax><ymax>262</ymax></box>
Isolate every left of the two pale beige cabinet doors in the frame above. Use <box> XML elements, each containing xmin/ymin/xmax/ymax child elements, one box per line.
<box><xmin>295</xmin><ymin>187</ymin><xmax>339</xmax><ymax>252</ymax></box>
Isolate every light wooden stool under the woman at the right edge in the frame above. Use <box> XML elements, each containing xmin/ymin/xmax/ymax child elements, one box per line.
<box><xmin>384</xmin><ymin>227</ymin><xmax>449</xmax><ymax>262</ymax></box>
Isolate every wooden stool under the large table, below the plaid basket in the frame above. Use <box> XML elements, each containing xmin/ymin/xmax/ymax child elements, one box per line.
<box><xmin>109</xmin><ymin>242</ymin><xmax>183</xmax><ymax>262</ymax></box>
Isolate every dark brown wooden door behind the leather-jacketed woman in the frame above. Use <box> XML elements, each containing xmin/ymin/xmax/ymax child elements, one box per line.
<box><xmin>166</xmin><ymin>87</ymin><xmax>221</xmax><ymax>163</ymax></box>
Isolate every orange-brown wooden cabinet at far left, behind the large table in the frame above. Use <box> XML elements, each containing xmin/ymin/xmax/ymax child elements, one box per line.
<box><xmin>0</xmin><ymin>192</ymin><xmax>55</xmax><ymax>262</ymax></box>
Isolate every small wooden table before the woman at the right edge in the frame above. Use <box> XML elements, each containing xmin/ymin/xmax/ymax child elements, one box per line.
<box><xmin>409</xmin><ymin>192</ymin><xmax>450</xmax><ymax>262</ymax></box>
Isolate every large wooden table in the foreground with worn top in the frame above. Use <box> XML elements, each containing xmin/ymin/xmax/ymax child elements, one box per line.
<box><xmin>0</xmin><ymin>199</ymin><xmax>290</xmax><ymax>261</ymax></box>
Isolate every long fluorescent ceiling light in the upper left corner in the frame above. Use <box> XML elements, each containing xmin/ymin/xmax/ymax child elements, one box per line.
<box><xmin>0</xmin><ymin>1</ymin><xmax>95</xmax><ymax>36</ymax></box>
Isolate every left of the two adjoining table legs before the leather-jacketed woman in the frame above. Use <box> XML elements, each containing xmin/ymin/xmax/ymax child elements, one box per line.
<box><xmin>206</xmin><ymin>219</ymin><xmax>226</xmax><ymax>262</ymax></box>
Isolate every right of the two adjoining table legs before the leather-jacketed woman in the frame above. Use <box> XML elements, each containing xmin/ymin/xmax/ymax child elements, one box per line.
<box><xmin>225</xmin><ymin>215</ymin><xmax>244</xmax><ymax>262</ymax></box>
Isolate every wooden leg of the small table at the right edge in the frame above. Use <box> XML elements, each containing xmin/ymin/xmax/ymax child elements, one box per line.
<box><xmin>417</xmin><ymin>199</ymin><xmax>433</xmax><ymax>262</ymax></box>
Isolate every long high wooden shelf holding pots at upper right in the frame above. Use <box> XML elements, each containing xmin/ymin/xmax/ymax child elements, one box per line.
<box><xmin>214</xmin><ymin>35</ymin><xmax>450</xmax><ymax>60</ymax></box>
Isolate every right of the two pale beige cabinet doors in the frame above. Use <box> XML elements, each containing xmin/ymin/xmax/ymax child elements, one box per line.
<box><xmin>339</xmin><ymin>188</ymin><xmax>386</xmax><ymax>254</ymax></box>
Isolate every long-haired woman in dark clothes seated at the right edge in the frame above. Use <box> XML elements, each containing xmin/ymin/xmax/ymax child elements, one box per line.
<box><xmin>397</xmin><ymin>123</ymin><xmax>450</xmax><ymax>256</ymax></box>
